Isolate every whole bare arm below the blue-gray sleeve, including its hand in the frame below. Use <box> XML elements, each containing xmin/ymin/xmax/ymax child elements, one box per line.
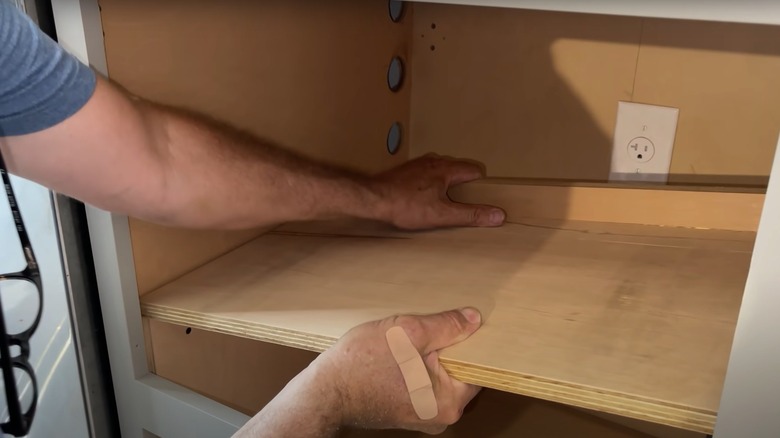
<box><xmin>0</xmin><ymin>79</ymin><xmax>504</xmax><ymax>229</ymax></box>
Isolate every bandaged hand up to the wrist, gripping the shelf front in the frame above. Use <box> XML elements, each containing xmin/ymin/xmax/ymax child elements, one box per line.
<box><xmin>317</xmin><ymin>308</ymin><xmax>481</xmax><ymax>433</ymax></box>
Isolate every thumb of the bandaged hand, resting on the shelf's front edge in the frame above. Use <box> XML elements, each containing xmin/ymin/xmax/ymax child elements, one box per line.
<box><xmin>418</xmin><ymin>307</ymin><xmax>482</xmax><ymax>355</ymax></box>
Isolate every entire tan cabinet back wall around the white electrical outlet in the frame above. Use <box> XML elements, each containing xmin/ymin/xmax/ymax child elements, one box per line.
<box><xmin>412</xmin><ymin>3</ymin><xmax>780</xmax><ymax>185</ymax></box>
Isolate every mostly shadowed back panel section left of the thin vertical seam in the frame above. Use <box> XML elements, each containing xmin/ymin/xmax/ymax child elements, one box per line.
<box><xmin>412</xmin><ymin>4</ymin><xmax>641</xmax><ymax>179</ymax></box>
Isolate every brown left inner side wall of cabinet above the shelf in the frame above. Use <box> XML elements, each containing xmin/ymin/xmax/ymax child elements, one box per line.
<box><xmin>100</xmin><ymin>0</ymin><xmax>412</xmax><ymax>293</ymax></box>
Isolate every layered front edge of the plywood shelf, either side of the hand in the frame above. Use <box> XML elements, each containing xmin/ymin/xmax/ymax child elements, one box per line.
<box><xmin>142</xmin><ymin>303</ymin><xmax>716</xmax><ymax>433</ymax></box>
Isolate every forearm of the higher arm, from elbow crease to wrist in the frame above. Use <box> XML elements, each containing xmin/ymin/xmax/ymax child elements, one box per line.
<box><xmin>136</xmin><ymin>102</ymin><xmax>386</xmax><ymax>228</ymax></box>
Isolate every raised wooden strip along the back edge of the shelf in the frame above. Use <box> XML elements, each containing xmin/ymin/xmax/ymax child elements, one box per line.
<box><xmin>449</xmin><ymin>180</ymin><xmax>764</xmax><ymax>232</ymax></box>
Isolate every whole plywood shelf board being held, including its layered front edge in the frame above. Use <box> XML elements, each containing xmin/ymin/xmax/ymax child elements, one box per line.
<box><xmin>142</xmin><ymin>219</ymin><xmax>755</xmax><ymax>432</ymax></box>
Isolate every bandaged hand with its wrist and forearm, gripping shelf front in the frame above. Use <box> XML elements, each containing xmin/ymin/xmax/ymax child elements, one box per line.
<box><xmin>235</xmin><ymin>308</ymin><xmax>481</xmax><ymax>438</ymax></box>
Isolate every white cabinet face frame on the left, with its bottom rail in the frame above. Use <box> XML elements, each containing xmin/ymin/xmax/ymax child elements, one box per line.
<box><xmin>52</xmin><ymin>0</ymin><xmax>249</xmax><ymax>438</ymax></box>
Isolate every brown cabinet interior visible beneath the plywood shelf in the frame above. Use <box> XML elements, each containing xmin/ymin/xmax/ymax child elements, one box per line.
<box><xmin>150</xmin><ymin>320</ymin><xmax>676</xmax><ymax>438</ymax></box>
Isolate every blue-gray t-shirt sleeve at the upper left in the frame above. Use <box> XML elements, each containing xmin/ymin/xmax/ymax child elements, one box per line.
<box><xmin>0</xmin><ymin>0</ymin><xmax>97</xmax><ymax>137</ymax></box>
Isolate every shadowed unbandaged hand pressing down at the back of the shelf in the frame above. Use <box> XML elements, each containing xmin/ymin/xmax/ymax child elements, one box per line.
<box><xmin>374</xmin><ymin>154</ymin><xmax>506</xmax><ymax>230</ymax></box>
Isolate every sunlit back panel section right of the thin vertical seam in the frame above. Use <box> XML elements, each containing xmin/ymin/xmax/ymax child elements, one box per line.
<box><xmin>634</xmin><ymin>20</ymin><xmax>780</xmax><ymax>186</ymax></box>
